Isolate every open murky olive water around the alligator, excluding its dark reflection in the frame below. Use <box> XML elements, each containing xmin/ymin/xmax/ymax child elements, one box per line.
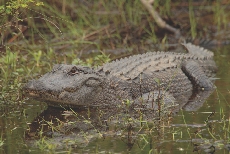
<box><xmin>0</xmin><ymin>46</ymin><xmax>230</xmax><ymax>154</ymax></box>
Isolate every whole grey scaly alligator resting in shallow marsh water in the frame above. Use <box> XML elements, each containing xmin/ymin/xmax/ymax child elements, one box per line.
<box><xmin>23</xmin><ymin>43</ymin><xmax>217</xmax><ymax>107</ymax></box>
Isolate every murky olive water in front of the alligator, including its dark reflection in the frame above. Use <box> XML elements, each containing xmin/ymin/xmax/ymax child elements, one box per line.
<box><xmin>0</xmin><ymin>47</ymin><xmax>230</xmax><ymax>153</ymax></box>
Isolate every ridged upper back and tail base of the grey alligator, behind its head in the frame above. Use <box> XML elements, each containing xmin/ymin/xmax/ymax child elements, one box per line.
<box><xmin>100</xmin><ymin>43</ymin><xmax>216</xmax><ymax>80</ymax></box>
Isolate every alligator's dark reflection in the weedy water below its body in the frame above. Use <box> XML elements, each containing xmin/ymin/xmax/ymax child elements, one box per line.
<box><xmin>26</xmin><ymin>88</ymin><xmax>213</xmax><ymax>152</ymax></box>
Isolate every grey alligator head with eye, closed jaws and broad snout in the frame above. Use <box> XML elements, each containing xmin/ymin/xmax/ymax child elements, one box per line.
<box><xmin>23</xmin><ymin>64</ymin><xmax>104</xmax><ymax>106</ymax></box>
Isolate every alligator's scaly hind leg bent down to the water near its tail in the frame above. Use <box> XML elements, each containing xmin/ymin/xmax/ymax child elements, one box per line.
<box><xmin>181</xmin><ymin>60</ymin><xmax>215</xmax><ymax>90</ymax></box>
